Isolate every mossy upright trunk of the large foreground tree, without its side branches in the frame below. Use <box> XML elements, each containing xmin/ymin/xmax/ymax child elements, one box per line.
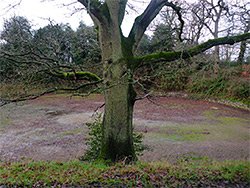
<box><xmin>91</xmin><ymin>0</ymin><xmax>136</xmax><ymax>161</ymax></box>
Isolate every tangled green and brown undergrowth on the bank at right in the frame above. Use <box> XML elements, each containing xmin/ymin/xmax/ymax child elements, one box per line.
<box><xmin>156</xmin><ymin>65</ymin><xmax>250</xmax><ymax>106</ymax></box>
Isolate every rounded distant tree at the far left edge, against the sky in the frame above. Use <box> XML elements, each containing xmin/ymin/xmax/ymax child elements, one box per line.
<box><xmin>0</xmin><ymin>16</ymin><xmax>32</xmax><ymax>76</ymax></box>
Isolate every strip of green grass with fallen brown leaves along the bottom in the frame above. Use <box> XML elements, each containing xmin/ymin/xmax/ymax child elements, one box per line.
<box><xmin>0</xmin><ymin>157</ymin><xmax>250</xmax><ymax>187</ymax></box>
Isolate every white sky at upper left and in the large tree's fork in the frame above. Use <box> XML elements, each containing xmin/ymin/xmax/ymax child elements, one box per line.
<box><xmin>0</xmin><ymin>0</ymin><xmax>196</xmax><ymax>35</ymax></box>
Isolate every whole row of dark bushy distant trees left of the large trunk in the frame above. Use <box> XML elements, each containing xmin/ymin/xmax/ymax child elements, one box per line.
<box><xmin>0</xmin><ymin>17</ymin><xmax>102</xmax><ymax>81</ymax></box>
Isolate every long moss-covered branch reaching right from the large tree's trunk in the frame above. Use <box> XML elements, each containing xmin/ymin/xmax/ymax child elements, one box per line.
<box><xmin>134</xmin><ymin>33</ymin><xmax>250</xmax><ymax>68</ymax></box>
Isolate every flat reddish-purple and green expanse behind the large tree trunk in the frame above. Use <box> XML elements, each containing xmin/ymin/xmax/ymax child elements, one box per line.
<box><xmin>0</xmin><ymin>95</ymin><xmax>250</xmax><ymax>161</ymax></box>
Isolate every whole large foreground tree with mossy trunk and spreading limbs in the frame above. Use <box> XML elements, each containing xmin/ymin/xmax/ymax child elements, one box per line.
<box><xmin>1</xmin><ymin>0</ymin><xmax>250</xmax><ymax>161</ymax></box>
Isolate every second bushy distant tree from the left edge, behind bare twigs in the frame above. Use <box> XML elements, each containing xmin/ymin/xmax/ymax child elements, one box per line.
<box><xmin>30</xmin><ymin>24</ymin><xmax>74</xmax><ymax>76</ymax></box>
